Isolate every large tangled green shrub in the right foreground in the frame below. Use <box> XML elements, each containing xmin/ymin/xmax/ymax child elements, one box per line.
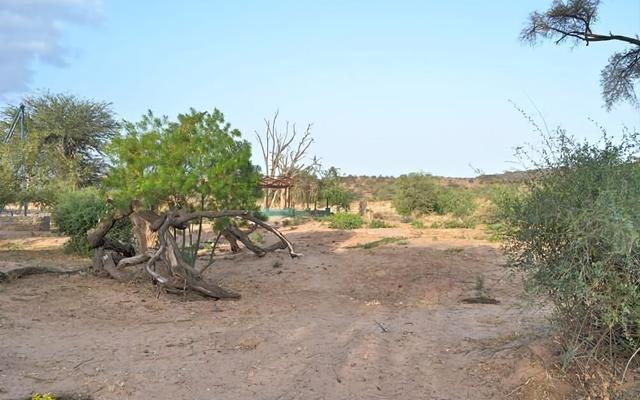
<box><xmin>500</xmin><ymin>131</ymin><xmax>640</xmax><ymax>357</ymax></box>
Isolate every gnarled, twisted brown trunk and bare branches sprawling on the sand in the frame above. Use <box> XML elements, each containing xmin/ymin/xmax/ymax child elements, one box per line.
<box><xmin>87</xmin><ymin>209</ymin><xmax>300</xmax><ymax>299</ymax></box>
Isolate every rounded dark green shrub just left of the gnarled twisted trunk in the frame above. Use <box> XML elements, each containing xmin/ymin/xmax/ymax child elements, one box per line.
<box><xmin>51</xmin><ymin>188</ymin><xmax>131</xmax><ymax>254</ymax></box>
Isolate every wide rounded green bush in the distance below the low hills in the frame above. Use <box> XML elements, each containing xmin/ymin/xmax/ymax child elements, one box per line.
<box><xmin>393</xmin><ymin>173</ymin><xmax>476</xmax><ymax>217</ymax></box>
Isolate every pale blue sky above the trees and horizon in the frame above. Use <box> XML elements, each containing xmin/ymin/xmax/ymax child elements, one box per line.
<box><xmin>0</xmin><ymin>0</ymin><xmax>640</xmax><ymax>177</ymax></box>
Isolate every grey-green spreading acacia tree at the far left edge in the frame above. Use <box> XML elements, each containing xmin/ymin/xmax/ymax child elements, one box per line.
<box><xmin>0</xmin><ymin>93</ymin><xmax>119</xmax><ymax>212</ymax></box>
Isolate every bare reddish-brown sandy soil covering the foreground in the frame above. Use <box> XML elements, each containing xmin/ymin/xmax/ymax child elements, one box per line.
<box><xmin>0</xmin><ymin>223</ymin><xmax>561</xmax><ymax>400</ymax></box>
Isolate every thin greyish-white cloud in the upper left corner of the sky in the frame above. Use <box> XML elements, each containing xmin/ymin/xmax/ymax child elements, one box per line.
<box><xmin>0</xmin><ymin>0</ymin><xmax>101</xmax><ymax>96</ymax></box>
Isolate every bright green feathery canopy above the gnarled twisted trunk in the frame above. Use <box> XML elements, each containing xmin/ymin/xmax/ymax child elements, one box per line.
<box><xmin>105</xmin><ymin>109</ymin><xmax>260</xmax><ymax>210</ymax></box>
